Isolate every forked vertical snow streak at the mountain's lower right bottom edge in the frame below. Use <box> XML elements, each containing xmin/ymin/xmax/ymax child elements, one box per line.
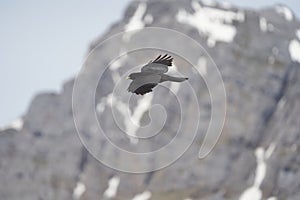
<box><xmin>239</xmin><ymin>143</ymin><xmax>276</xmax><ymax>200</ymax></box>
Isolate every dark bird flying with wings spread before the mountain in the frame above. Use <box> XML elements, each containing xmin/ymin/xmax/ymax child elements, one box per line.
<box><xmin>127</xmin><ymin>54</ymin><xmax>188</xmax><ymax>95</ymax></box>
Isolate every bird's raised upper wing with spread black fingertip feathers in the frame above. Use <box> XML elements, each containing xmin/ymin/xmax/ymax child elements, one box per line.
<box><xmin>141</xmin><ymin>54</ymin><xmax>173</xmax><ymax>74</ymax></box>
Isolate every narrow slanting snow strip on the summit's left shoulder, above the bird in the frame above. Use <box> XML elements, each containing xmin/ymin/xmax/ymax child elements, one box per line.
<box><xmin>123</xmin><ymin>2</ymin><xmax>147</xmax><ymax>42</ymax></box>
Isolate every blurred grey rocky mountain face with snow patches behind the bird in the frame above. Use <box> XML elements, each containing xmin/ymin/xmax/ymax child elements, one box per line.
<box><xmin>0</xmin><ymin>0</ymin><xmax>300</xmax><ymax>200</ymax></box>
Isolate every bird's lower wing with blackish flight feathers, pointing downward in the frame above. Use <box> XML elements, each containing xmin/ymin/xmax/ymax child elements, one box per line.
<box><xmin>128</xmin><ymin>73</ymin><xmax>161</xmax><ymax>95</ymax></box>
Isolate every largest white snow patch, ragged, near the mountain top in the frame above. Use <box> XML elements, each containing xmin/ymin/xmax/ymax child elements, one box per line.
<box><xmin>176</xmin><ymin>1</ymin><xmax>245</xmax><ymax>47</ymax></box>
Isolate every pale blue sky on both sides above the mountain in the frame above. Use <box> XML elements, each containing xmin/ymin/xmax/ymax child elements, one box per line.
<box><xmin>0</xmin><ymin>0</ymin><xmax>300</xmax><ymax>127</ymax></box>
